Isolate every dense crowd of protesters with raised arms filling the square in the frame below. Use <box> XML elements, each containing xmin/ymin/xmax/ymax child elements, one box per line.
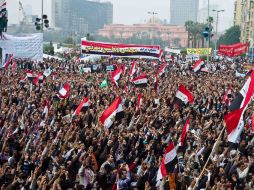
<box><xmin>0</xmin><ymin>52</ymin><xmax>254</xmax><ymax>190</ymax></box>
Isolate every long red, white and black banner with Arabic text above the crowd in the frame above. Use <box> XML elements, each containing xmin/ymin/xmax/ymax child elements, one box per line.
<box><xmin>81</xmin><ymin>39</ymin><xmax>162</xmax><ymax>59</ymax></box>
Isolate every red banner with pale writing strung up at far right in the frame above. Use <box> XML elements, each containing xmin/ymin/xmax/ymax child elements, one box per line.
<box><xmin>219</xmin><ymin>43</ymin><xmax>248</xmax><ymax>57</ymax></box>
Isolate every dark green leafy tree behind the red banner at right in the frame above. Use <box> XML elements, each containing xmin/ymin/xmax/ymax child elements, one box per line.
<box><xmin>217</xmin><ymin>26</ymin><xmax>241</xmax><ymax>46</ymax></box>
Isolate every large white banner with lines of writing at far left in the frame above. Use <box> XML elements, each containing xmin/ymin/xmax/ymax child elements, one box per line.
<box><xmin>0</xmin><ymin>33</ymin><xmax>43</xmax><ymax>61</ymax></box>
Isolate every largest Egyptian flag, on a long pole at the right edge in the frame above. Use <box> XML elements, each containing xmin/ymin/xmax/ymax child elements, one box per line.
<box><xmin>224</xmin><ymin>72</ymin><xmax>254</xmax><ymax>143</ymax></box>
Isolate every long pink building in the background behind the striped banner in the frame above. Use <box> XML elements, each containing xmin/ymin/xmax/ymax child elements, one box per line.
<box><xmin>97</xmin><ymin>23</ymin><xmax>188</xmax><ymax>48</ymax></box>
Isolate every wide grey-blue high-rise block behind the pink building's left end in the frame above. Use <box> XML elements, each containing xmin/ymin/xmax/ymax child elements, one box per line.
<box><xmin>52</xmin><ymin>0</ymin><xmax>113</xmax><ymax>34</ymax></box>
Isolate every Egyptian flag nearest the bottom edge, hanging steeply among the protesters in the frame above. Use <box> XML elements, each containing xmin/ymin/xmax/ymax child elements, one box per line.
<box><xmin>157</xmin><ymin>142</ymin><xmax>178</xmax><ymax>181</ymax></box>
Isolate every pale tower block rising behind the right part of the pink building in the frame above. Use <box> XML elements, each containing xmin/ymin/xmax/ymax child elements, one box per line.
<box><xmin>170</xmin><ymin>0</ymin><xmax>199</xmax><ymax>26</ymax></box>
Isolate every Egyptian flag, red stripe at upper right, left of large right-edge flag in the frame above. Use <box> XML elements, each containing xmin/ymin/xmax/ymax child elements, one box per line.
<box><xmin>175</xmin><ymin>85</ymin><xmax>194</xmax><ymax>106</ymax></box>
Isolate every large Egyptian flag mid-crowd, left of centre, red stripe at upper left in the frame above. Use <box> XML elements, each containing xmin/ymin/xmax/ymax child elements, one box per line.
<box><xmin>100</xmin><ymin>97</ymin><xmax>124</xmax><ymax>129</ymax></box>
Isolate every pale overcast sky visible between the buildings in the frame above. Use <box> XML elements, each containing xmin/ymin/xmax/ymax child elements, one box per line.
<box><xmin>8</xmin><ymin>0</ymin><xmax>234</xmax><ymax>31</ymax></box>
